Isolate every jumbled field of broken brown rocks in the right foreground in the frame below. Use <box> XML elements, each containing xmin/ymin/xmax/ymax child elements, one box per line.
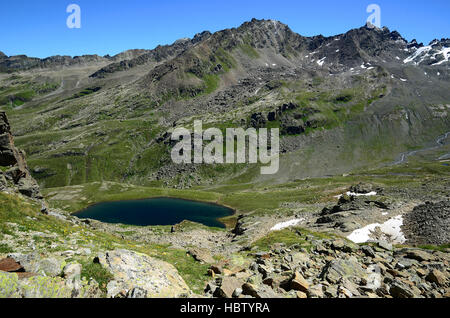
<box><xmin>205</xmin><ymin>236</ymin><xmax>450</xmax><ymax>298</ymax></box>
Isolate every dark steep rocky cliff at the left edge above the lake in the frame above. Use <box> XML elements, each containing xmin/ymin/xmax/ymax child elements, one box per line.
<box><xmin>0</xmin><ymin>112</ymin><xmax>42</xmax><ymax>199</ymax></box>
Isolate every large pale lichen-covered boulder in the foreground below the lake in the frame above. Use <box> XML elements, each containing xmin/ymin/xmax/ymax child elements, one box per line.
<box><xmin>96</xmin><ymin>249</ymin><xmax>190</xmax><ymax>298</ymax></box>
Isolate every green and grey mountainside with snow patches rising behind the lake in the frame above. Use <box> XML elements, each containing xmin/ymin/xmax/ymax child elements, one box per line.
<box><xmin>0</xmin><ymin>19</ymin><xmax>450</xmax><ymax>187</ymax></box>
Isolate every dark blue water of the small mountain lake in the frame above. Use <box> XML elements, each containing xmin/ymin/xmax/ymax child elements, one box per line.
<box><xmin>74</xmin><ymin>198</ymin><xmax>233</xmax><ymax>228</ymax></box>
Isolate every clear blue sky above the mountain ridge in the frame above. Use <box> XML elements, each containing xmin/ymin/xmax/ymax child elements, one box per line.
<box><xmin>0</xmin><ymin>0</ymin><xmax>450</xmax><ymax>57</ymax></box>
